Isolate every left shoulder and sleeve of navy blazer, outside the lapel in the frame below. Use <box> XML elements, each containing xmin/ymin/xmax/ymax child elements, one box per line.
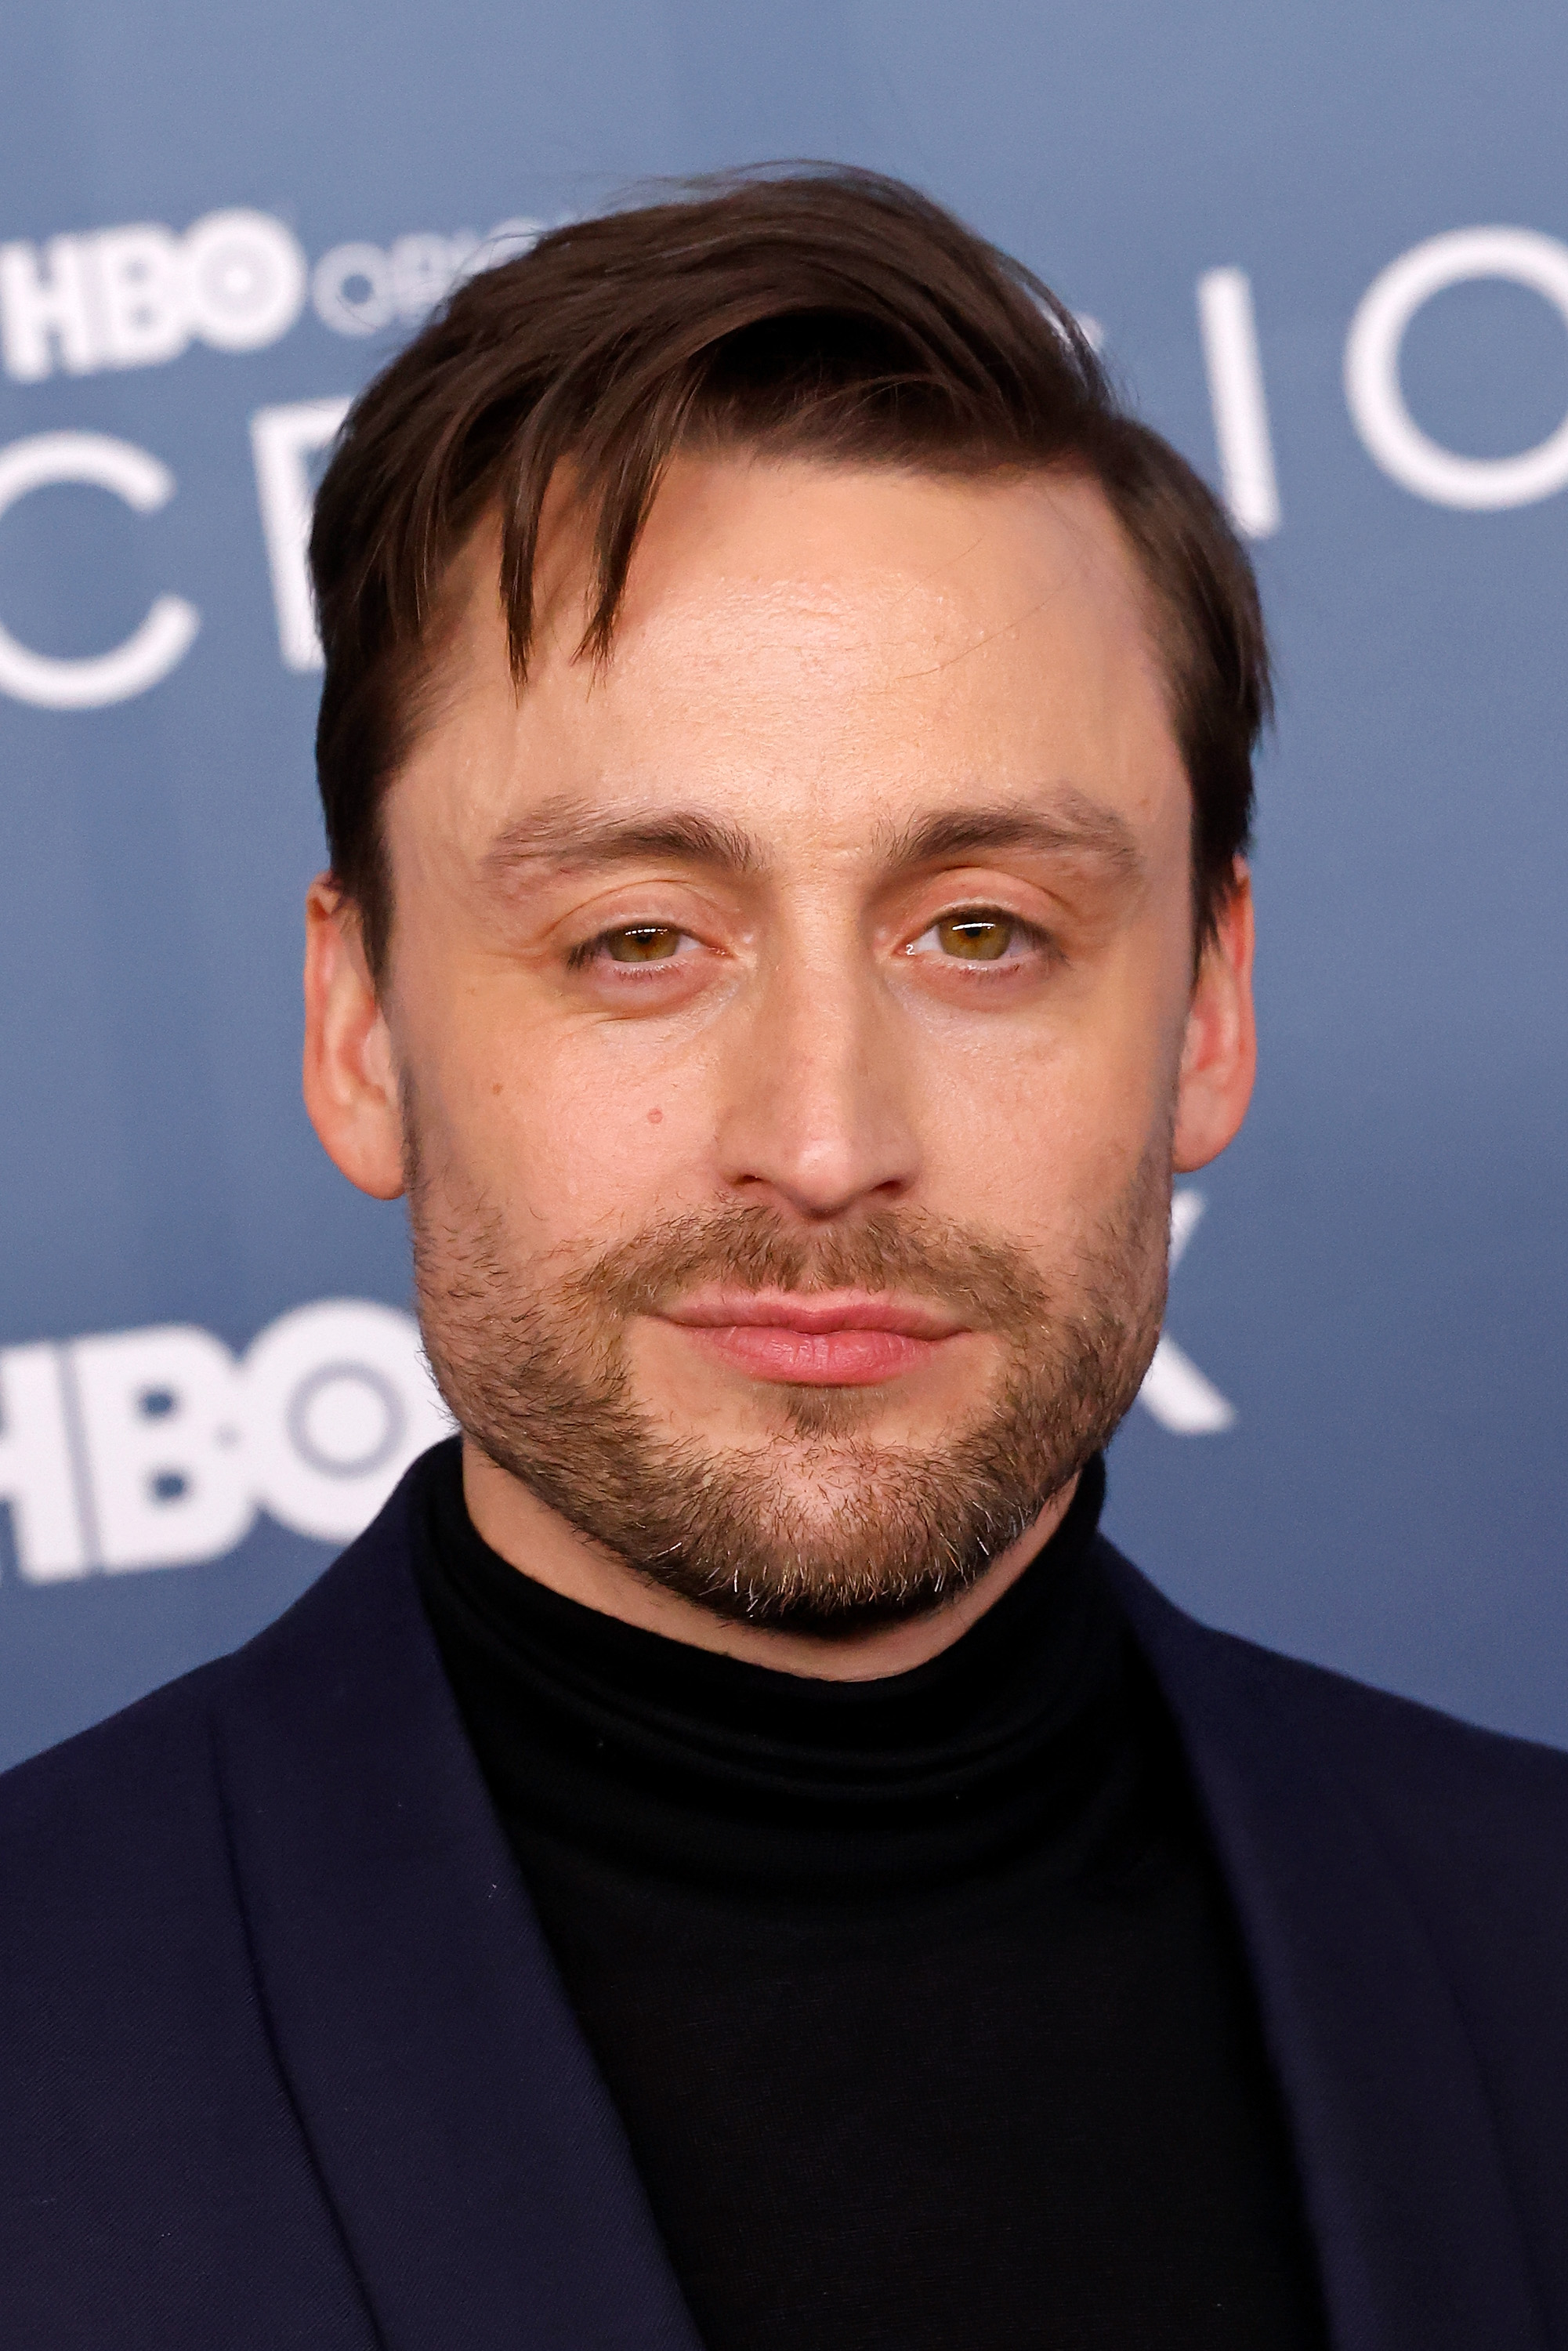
<box><xmin>0</xmin><ymin>1476</ymin><xmax>416</xmax><ymax>2351</ymax></box>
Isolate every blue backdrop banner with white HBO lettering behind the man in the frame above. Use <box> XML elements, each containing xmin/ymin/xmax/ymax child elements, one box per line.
<box><xmin>0</xmin><ymin>0</ymin><xmax>1568</xmax><ymax>1761</ymax></box>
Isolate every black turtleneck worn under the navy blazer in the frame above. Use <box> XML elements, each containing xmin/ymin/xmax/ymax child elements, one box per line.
<box><xmin>421</xmin><ymin>1444</ymin><xmax>1326</xmax><ymax>2351</ymax></box>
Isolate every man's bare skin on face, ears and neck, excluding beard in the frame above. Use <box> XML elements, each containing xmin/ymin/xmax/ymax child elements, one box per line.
<box><xmin>306</xmin><ymin>456</ymin><xmax>1255</xmax><ymax>1679</ymax></box>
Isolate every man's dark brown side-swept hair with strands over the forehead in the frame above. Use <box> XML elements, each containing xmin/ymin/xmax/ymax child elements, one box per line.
<box><xmin>310</xmin><ymin>167</ymin><xmax>1269</xmax><ymax>971</ymax></box>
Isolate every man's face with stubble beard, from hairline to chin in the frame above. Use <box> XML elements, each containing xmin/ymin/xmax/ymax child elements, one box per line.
<box><xmin>313</xmin><ymin>458</ymin><xmax>1251</xmax><ymax>1625</ymax></box>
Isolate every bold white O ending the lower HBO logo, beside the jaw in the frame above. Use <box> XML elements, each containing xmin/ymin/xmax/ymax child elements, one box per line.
<box><xmin>242</xmin><ymin>1298</ymin><xmax>451</xmax><ymax>1542</ymax></box>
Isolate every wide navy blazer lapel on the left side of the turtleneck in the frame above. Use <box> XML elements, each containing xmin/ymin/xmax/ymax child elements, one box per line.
<box><xmin>219</xmin><ymin>1486</ymin><xmax>698</xmax><ymax>2351</ymax></box>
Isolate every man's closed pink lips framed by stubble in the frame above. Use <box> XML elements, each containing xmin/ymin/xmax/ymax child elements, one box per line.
<box><xmin>663</xmin><ymin>1291</ymin><xmax>964</xmax><ymax>1387</ymax></box>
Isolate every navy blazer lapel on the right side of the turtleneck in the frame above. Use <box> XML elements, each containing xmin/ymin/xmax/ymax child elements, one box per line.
<box><xmin>1107</xmin><ymin>1547</ymin><xmax>1547</xmax><ymax>2351</ymax></box>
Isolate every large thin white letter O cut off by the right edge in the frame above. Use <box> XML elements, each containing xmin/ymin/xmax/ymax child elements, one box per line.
<box><xmin>1345</xmin><ymin>228</ymin><xmax>1568</xmax><ymax>513</ymax></box>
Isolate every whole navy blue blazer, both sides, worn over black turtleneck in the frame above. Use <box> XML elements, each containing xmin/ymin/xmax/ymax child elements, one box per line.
<box><xmin>0</xmin><ymin>1458</ymin><xmax>1568</xmax><ymax>2351</ymax></box>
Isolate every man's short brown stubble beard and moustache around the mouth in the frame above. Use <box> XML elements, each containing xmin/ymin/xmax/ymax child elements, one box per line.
<box><xmin>407</xmin><ymin>1131</ymin><xmax>1171</xmax><ymax>1634</ymax></box>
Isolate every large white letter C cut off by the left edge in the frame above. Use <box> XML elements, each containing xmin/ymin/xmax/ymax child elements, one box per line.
<box><xmin>0</xmin><ymin>433</ymin><xmax>202</xmax><ymax>710</ymax></box>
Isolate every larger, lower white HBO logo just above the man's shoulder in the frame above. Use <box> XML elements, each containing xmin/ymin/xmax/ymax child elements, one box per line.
<box><xmin>0</xmin><ymin>1298</ymin><xmax>451</xmax><ymax>1582</ymax></box>
